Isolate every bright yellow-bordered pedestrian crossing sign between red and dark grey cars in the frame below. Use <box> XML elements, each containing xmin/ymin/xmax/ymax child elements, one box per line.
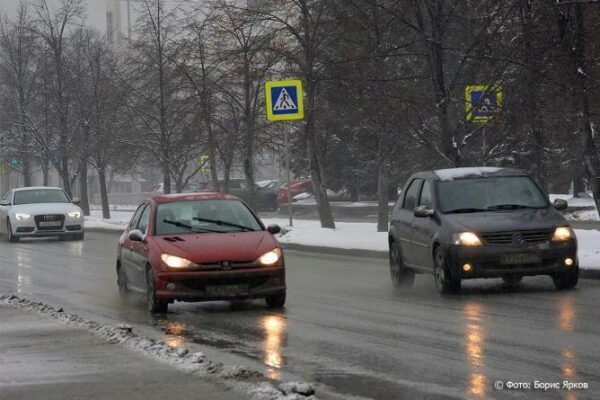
<box><xmin>265</xmin><ymin>80</ymin><xmax>304</xmax><ymax>121</ymax></box>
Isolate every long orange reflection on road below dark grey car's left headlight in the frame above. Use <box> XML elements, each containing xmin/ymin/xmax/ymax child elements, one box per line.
<box><xmin>463</xmin><ymin>303</ymin><xmax>488</xmax><ymax>397</ymax></box>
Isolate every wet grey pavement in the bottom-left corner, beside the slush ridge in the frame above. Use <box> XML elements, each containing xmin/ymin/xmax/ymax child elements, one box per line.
<box><xmin>0</xmin><ymin>305</ymin><xmax>244</xmax><ymax>400</ymax></box>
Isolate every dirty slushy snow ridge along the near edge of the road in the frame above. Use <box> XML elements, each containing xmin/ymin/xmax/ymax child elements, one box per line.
<box><xmin>0</xmin><ymin>295</ymin><xmax>316</xmax><ymax>400</ymax></box>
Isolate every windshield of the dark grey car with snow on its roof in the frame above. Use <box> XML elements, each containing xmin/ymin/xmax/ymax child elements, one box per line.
<box><xmin>438</xmin><ymin>176</ymin><xmax>549</xmax><ymax>213</ymax></box>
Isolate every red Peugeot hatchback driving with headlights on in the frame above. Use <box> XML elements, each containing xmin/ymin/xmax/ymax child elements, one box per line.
<box><xmin>117</xmin><ymin>193</ymin><xmax>286</xmax><ymax>312</ymax></box>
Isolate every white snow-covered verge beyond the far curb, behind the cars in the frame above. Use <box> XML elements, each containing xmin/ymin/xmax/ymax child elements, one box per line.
<box><xmin>86</xmin><ymin>210</ymin><xmax>600</xmax><ymax>270</ymax></box>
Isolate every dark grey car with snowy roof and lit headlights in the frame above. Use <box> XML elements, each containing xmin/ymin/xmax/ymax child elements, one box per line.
<box><xmin>389</xmin><ymin>167</ymin><xmax>579</xmax><ymax>293</ymax></box>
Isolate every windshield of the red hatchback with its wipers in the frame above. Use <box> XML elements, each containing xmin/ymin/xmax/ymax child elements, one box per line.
<box><xmin>154</xmin><ymin>200</ymin><xmax>262</xmax><ymax>235</ymax></box>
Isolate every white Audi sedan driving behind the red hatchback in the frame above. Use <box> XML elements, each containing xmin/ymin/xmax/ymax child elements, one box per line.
<box><xmin>0</xmin><ymin>187</ymin><xmax>84</xmax><ymax>242</ymax></box>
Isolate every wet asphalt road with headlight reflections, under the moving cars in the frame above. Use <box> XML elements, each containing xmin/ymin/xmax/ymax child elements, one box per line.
<box><xmin>0</xmin><ymin>232</ymin><xmax>600</xmax><ymax>400</ymax></box>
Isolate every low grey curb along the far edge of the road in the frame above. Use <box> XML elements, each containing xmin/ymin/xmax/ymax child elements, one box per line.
<box><xmin>85</xmin><ymin>228</ymin><xmax>600</xmax><ymax>280</ymax></box>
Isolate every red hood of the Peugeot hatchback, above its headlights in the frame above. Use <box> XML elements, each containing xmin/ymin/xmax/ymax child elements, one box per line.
<box><xmin>152</xmin><ymin>231</ymin><xmax>279</xmax><ymax>263</ymax></box>
